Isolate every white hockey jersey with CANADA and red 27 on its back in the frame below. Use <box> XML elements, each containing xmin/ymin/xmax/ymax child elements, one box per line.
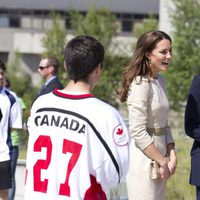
<box><xmin>25</xmin><ymin>90</ymin><xmax>130</xmax><ymax>200</ymax></box>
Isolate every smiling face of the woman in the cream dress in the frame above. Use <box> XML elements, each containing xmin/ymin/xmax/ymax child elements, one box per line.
<box><xmin>148</xmin><ymin>39</ymin><xmax>172</xmax><ymax>77</ymax></box>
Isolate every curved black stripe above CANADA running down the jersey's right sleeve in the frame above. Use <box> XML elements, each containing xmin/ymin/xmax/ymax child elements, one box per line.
<box><xmin>36</xmin><ymin>108</ymin><xmax>120</xmax><ymax>183</ymax></box>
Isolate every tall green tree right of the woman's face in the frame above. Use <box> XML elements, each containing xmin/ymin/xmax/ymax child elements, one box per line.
<box><xmin>166</xmin><ymin>0</ymin><xmax>200</xmax><ymax>110</ymax></box>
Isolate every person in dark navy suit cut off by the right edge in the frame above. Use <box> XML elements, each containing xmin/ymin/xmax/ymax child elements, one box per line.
<box><xmin>185</xmin><ymin>75</ymin><xmax>200</xmax><ymax>200</ymax></box>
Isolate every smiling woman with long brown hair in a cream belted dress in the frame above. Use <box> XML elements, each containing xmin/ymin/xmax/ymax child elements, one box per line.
<box><xmin>119</xmin><ymin>31</ymin><xmax>177</xmax><ymax>200</ymax></box>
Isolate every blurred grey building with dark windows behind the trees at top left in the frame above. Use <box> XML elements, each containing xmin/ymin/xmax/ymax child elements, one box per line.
<box><xmin>0</xmin><ymin>0</ymin><xmax>159</xmax><ymax>84</ymax></box>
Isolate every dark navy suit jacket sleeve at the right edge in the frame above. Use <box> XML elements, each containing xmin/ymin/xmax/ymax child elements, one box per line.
<box><xmin>185</xmin><ymin>75</ymin><xmax>200</xmax><ymax>142</ymax></box>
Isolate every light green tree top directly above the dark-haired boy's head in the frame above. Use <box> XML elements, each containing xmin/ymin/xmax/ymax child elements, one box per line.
<box><xmin>70</xmin><ymin>8</ymin><xmax>118</xmax><ymax>48</ymax></box>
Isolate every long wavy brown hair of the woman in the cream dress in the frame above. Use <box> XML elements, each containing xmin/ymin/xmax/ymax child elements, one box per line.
<box><xmin>117</xmin><ymin>31</ymin><xmax>172</xmax><ymax>102</ymax></box>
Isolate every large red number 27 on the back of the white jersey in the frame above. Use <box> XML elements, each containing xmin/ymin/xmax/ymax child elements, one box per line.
<box><xmin>33</xmin><ymin>135</ymin><xmax>82</xmax><ymax>197</ymax></box>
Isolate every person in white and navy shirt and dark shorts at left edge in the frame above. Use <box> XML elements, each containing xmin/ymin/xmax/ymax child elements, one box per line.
<box><xmin>0</xmin><ymin>60</ymin><xmax>22</xmax><ymax>200</ymax></box>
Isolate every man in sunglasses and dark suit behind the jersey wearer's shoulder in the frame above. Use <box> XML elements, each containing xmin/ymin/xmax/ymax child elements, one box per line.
<box><xmin>37</xmin><ymin>57</ymin><xmax>63</xmax><ymax>97</ymax></box>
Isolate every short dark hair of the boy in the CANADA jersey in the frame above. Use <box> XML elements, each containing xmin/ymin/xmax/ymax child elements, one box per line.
<box><xmin>64</xmin><ymin>35</ymin><xmax>104</xmax><ymax>82</ymax></box>
